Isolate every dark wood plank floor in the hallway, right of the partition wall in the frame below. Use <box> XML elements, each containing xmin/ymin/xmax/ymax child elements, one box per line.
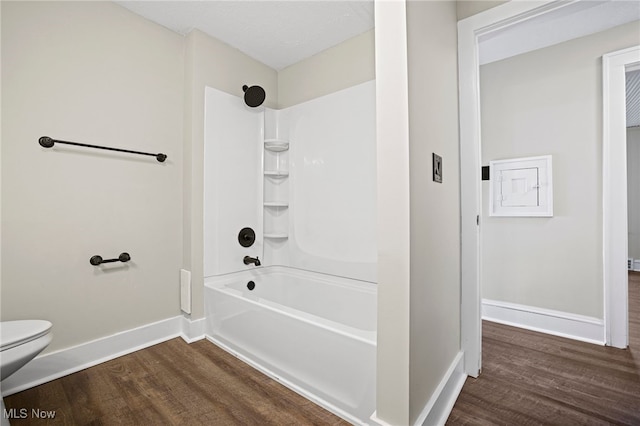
<box><xmin>447</xmin><ymin>272</ymin><xmax>640</xmax><ymax>426</ymax></box>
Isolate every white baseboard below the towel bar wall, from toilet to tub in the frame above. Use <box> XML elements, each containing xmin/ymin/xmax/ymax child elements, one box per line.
<box><xmin>2</xmin><ymin>315</ymin><xmax>205</xmax><ymax>396</ymax></box>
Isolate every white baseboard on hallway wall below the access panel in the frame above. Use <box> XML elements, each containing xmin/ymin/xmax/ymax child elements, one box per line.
<box><xmin>482</xmin><ymin>299</ymin><xmax>605</xmax><ymax>345</ymax></box>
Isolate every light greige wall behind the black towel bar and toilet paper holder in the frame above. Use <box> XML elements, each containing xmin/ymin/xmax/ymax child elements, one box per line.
<box><xmin>1</xmin><ymin>2</ymin><xmax>184</xmax><ymax>351</ymax></box>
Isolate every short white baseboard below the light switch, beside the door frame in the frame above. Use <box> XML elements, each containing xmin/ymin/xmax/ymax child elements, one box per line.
<box><xmin>415</xmin><ymin>352</ymin><xmax>467</xmax><ymax>426</ymax></box>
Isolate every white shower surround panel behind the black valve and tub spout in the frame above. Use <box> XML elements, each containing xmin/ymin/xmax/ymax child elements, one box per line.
<box><xmin>204</xmin><ymin>87</ymin><xmax>264</xmax><ymax>277</ymax></box>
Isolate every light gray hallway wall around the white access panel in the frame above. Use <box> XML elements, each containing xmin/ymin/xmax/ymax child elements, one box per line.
<box><xmin>480</xmin><ymin>22</ymin><xmax>640</xmax><ymax>318</ymax></box>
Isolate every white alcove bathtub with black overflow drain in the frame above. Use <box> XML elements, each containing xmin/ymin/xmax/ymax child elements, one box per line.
<box><xmin>205</xmin><ymin>266</ymin><xmax>377</xmax><ymax>424</ymax></box>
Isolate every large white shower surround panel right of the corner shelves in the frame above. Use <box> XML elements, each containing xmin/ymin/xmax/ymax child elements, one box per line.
<box><xmin>278</xmin><ymin>81</ymin><xmax>377</xmax><ymax>281</ymax></box>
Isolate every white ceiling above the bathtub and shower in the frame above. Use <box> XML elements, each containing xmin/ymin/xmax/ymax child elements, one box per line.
<box><xmin>116</xmin><ymin>0</ymin><xmax>374</xmax><ymax>70</ymax></box>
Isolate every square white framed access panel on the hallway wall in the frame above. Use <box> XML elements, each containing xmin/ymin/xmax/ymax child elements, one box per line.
<box><xmin>489</xmin><ymin>155</ymin><xmax>553</xmax><ymax>217</ymax></box>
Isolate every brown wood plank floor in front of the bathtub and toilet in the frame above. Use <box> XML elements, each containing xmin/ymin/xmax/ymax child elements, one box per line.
<box><xmin>5</xmin><ymin>338</ymin><xmax>349</xmax><ymax>426</ymax></box>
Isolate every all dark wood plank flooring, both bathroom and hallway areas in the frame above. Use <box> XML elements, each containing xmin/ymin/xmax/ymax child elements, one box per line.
<box><xmin>5</xmin><ymin>273</ymin><xmax>640</xmax><ymax>426</ymax></box>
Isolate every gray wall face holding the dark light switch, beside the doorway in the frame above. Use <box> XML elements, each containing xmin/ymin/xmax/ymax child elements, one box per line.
<box><xmin>407</xmin><ymin>1</ymin><xmax>460</xmax><ymax>423</ymax></box>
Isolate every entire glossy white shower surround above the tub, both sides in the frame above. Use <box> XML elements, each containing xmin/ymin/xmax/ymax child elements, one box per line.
<box><xmin>204</xmin><ymin>80</ymin><xmax>377</xmax><ymax>282</ymax></box>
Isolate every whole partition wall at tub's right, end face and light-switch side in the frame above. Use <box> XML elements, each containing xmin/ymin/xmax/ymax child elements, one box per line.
<box><xmin>376</xmin><ymin>1</ymin><xmax>460</xmax><ymax>425</ymax></box>
